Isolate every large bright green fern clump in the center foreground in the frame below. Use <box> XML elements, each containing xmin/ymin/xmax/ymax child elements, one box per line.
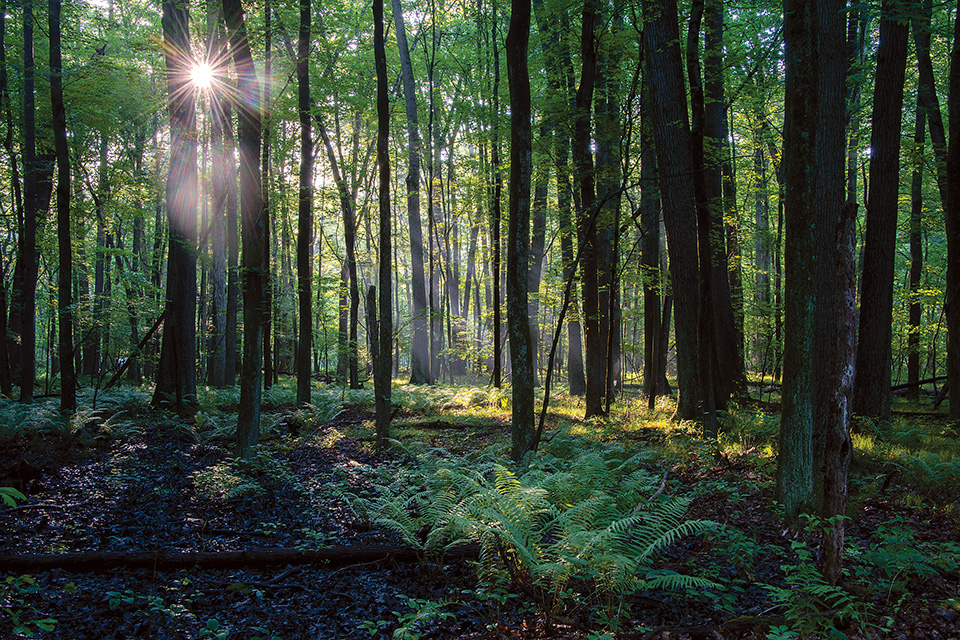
<box><xmin>355</xmin><ymin>451</ymin><xmax>716</xmax><ymax>624</ymax></box>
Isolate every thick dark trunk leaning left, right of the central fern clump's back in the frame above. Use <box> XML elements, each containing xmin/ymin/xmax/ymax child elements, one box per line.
<box><xmin>643</xmin><ymin>0</ymin><xmax>702</xmax><ymax>419</ymax></box>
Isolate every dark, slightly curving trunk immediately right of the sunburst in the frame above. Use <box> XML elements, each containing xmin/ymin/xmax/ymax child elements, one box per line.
<box><xmin>223</xmin><ymin>0</ymin><xmax>269</xmax><ymax>458</ymax></box>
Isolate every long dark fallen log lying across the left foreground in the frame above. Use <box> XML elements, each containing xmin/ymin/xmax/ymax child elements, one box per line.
<box><xmin>0</xmin><ymin>545</ymin><xmax>479</xmax><ymax>572</ymax></box>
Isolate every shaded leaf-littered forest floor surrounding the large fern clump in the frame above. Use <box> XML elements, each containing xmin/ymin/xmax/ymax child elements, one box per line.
<box><xmin>0</xmin><ymin>382</ymin><xmax>960</xmax><ymax>640</ymax></box>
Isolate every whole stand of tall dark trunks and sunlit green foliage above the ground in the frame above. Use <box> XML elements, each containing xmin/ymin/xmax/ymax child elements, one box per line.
<box><xmin>0</xmin><ymin>0</ymin><xmax>960</xmax><ymax>581</ymax></box>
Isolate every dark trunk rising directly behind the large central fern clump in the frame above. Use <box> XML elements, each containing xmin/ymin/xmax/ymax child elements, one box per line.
<box><xmin>506</xmin><ymin>0</ymin><xmax>536</xmax><ymax>462</ymax></box>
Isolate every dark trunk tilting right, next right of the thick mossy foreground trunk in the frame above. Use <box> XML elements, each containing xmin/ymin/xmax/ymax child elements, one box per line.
<box><xmin>852</xmin><ymin>0</ymin><xmax>912</xmax><ymax>420</ymax></box>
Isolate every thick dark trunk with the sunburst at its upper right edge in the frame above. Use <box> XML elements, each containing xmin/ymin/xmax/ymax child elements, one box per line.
<box><xmin>153</xmin><ymin>0</ymin><xmax>197</xmax><ymax>415</ymax></box>
